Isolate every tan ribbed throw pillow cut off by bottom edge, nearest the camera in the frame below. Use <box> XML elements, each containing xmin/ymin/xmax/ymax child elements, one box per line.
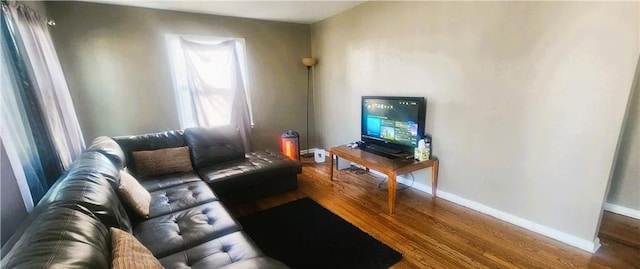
<box><xmin>109</xmin><ymin>228</ymin><xmax>164</xmax><ymax>269</ymax></box>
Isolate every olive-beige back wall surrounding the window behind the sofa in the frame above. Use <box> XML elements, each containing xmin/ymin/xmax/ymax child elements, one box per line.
<box><xmin>46</xmin><ymin>2</ymin><xmax>311</xmax><ymax>149</ymax></box>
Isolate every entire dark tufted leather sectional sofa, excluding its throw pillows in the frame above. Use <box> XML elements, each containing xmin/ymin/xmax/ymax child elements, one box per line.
<box><xmin>1</xmin><ymin>128</ymin><xmax>301</xmax><ymax>269</ymax></box>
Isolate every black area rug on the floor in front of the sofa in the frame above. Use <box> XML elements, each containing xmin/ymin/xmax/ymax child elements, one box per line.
<box><xmin>239</xmin><ymin>198</ymin><xmax>402</xmax><ymax>269</ymax></box>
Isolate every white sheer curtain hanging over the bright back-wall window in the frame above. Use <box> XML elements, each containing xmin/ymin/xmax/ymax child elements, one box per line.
<box><xmin>174</xmin><ymin>38</ymin><xmax>251</xmax><ymax>152</ymax></box>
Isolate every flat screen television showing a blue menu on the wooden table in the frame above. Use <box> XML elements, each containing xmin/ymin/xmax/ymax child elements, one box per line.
<box><xmin>361</xmin><ymin>96</ymin><xmax>427</xmax><ymax>154</ymax></box>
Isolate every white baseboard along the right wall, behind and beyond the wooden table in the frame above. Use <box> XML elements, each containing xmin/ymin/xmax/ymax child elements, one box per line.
<box><xmin>338</xmin><ymin>160</ymin><xmax>600</xmax><ymax>253</ymax></box>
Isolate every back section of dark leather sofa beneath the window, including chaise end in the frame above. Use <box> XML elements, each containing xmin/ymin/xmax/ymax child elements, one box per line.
<box><xmin>114</xmin><ymin>127</ymin><xmax>302</xmax><ymax>204</ymax></box>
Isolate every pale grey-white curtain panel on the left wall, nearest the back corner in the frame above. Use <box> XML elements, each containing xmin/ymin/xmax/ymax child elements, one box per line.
<box><xmin>8</xmin><ymin>1</ymin><xmax>85</xmax><ymax>169</ymax></box>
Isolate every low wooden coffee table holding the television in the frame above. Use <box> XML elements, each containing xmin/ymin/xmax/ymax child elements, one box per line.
<box><xmin>329</xmin><ymin>146</ymin><xmax>439</xmax><ymax>214</ymax></box>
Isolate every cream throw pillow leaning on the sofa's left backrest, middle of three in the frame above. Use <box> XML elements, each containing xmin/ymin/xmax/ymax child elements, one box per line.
<box><xmin>118</xmin><ymin>170</ymin><xmax>151</xmax><ymax>218</ymax></box>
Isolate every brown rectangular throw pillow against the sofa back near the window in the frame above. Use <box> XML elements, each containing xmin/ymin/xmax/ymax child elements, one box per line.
<box><xmin>132</xmin><ymin>146</ymin><xmax>193</xmax><ymax>177</ymax></box>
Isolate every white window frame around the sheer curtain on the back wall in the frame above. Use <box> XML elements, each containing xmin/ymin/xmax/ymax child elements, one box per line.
<box><xmin>165</xmin><ymin>34</ymin><xmax>255</xmax><ymax>129</ymax></box>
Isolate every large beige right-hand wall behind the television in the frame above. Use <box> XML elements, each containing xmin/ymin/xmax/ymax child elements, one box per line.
<box><xmin>311</xmin><ymin>2</ymin><xmax>640</xmax><ymax>241</ymax></box>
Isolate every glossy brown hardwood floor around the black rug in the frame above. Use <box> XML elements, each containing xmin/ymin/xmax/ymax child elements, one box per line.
<box><xmin>232</xmin><ymin>160</ymin><xmax>640</xmax><ymax>268</ymax></box>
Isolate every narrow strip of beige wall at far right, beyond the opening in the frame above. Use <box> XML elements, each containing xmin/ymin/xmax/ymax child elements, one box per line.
<box><xmin>607</xmin><ymin>57</ymin><xmax>640</xmax><ymax>209</ymax></box>
